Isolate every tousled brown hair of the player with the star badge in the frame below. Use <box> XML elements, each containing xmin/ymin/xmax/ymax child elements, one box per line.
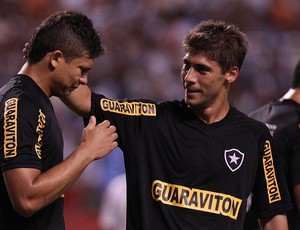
<box><xmin>183</xmin><ymin>20</ymin><xmax>248</xmax><ymax>73</ymax></box>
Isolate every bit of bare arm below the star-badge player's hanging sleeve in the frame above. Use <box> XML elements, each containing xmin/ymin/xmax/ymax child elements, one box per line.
<box><xmin>259</xmin><ymin>214</ymin><xmax>288</xmax><ymax>230</ymax></box>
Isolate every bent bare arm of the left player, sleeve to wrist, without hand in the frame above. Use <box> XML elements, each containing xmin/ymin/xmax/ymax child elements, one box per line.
<box><xmin>5</xmin><ymin>148</ymin><xmax>92</xmax><ymax>217</ymax></box>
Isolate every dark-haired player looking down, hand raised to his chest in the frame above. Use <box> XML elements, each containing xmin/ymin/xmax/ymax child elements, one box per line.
<box><xmin>0</xmin><ymin>11</ymin><xmax>117</xmax><ymax>230</ymax></box>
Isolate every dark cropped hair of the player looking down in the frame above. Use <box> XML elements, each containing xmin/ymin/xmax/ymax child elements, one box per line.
<box><xmin>26</xmin><ymin>11</ymin><xmax>104</xmax><ymax>64</ymax></box>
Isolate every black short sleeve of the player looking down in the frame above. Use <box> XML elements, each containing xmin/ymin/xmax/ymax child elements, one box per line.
<box><xmin>1</xmin><ymin>97</ymin><xmax>45</xmax><ymax>171</ymax></box>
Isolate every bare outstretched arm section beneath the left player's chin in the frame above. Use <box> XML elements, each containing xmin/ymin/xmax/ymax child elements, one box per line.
<box><xmin>60</xmin><ymin>85</ymin><xmax>92</xmax><ymax>117</ymax></box>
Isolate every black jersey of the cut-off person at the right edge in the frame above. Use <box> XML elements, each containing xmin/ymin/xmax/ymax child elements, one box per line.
<box><xmin>249</xmin><ymin>100</ymin><xmax>300</xmax><ymax>229</ymax></box>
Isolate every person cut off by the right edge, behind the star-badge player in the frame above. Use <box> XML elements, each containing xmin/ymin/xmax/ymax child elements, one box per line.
<box><xmin>246</xmin><ymin>59</ymin><xmax>300</xmax><ymax>230</ymax></box>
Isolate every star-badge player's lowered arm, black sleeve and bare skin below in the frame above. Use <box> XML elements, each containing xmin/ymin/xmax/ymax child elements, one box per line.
<box><xmin>253</xmin><ymin>129</ymin><xmax>291</xmax><ymax>230</ymax></box>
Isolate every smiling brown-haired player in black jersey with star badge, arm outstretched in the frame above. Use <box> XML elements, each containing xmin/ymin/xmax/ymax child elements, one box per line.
<box><xmin>61</xmin><ymin>20</ymin><xmax>291</xmax><ymax>230</ymax></box>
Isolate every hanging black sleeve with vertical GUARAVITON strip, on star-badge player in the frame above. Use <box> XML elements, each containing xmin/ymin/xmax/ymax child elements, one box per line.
<box><xmin>253</xmin><ymin>129</ymin><xmax>291</xmax><ymax>219</ymax></box>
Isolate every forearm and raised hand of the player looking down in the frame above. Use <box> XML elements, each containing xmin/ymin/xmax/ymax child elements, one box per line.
<box><xmin>22</xmin><ymin>128</ymin><xmax>117</xmax><ymax>217</ymax></box>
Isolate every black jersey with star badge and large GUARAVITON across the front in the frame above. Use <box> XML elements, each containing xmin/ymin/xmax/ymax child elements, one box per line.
<box><xmin>86</xmin><ymin>93</ymin><xmax>290</xmax><ymax>230</ymax></box>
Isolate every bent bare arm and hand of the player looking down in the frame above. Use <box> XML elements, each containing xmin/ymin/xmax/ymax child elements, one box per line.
<box><xmin>3</xmin><ymin>117</ymin><xmax>117</xmax><ymax>217</ymax></box>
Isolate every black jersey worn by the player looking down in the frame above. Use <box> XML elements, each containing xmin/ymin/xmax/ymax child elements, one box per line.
<box><xmin>0</xmin><ymin>75</ymin><xmax>65</xmax><ymax>230</ymax></box>
